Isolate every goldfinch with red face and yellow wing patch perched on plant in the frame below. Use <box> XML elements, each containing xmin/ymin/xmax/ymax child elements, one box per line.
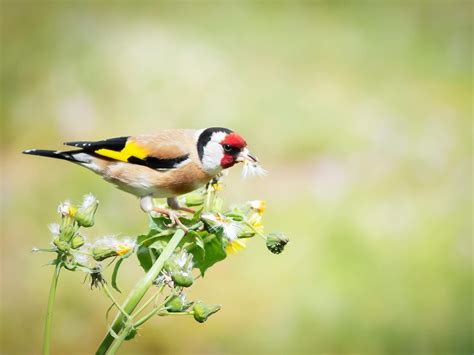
<box><xmin>23</xmin><ymin>127</ymin><xmax>259</xmax><ymax>226</ymax></box>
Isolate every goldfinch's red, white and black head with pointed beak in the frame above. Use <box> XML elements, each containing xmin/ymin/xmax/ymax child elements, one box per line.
<box><xmin>197</xmin><ymin>127</ymin><xmax>258</xmax><ymax>175</ymax></box>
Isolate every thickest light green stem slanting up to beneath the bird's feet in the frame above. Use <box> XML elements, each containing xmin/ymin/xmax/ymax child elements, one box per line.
<box><xmin>96</xmin><ymin>229</ymin><xmax>185</xmax><ymax>355</ymax></box>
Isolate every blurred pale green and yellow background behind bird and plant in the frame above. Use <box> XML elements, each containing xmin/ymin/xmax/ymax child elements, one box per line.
<box><xmin>1</xmin><ymin>1</ymin><xmax>474</xmax><ymax>354</ymax></box>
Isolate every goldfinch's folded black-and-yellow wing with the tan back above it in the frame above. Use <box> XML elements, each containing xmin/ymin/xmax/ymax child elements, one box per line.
<box><xmin>64</xmin><ymin>136</ymin><xmax>189</xmax><ymax>170</ymax></box>
